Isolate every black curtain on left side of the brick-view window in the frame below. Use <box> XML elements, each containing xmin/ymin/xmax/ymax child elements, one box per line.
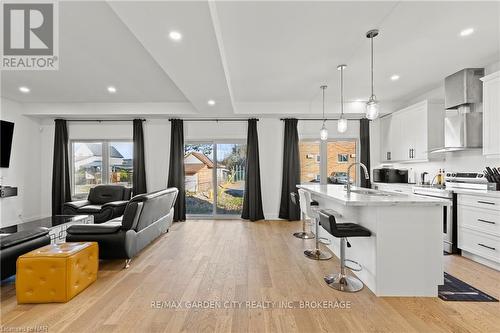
<box><xmin>279</xmin><ymin>118</ymin><xmax>300</xmax><ymax>221</ymax></box>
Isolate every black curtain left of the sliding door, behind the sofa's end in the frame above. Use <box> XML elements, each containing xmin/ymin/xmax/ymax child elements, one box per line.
<box><xmin>167</xmin><ymin>119</ymin><xmax>186</xmax><ymax>222</ymax></box>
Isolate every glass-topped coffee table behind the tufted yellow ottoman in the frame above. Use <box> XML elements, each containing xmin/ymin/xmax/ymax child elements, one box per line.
<box><xmin>0</xmin><ymin>215</ymin><xmax>94</xmax><ymax>244</ymax></box>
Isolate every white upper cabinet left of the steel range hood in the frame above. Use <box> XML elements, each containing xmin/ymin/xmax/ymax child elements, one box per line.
<box><xmin>380</xmin><ymin>100</ymin><xmax>445</xmax><ymax>162</ymax></box>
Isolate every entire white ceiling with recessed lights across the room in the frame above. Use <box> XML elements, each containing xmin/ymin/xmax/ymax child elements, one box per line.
<box><xmin>1</xmin><ymin>1</ymin><xmax>500</xmax><ymax>116</ymax></box>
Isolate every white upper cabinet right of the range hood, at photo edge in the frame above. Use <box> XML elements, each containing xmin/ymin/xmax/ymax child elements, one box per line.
<box><xmin>481</xmin><ymin>71</ymin><xmax>500</xmax><ymax>156</ymax></box>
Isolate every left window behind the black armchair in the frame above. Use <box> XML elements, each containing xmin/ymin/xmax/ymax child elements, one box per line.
<box><xmin>71</xmin><ymin>140</ymin><xmax>133</xmax><ymax>199</ymax></box>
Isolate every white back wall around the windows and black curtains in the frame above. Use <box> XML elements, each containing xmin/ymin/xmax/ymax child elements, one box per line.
<box><xmin>38</xmin><ymin>117</ymin><xmax>359</xmax><ymax>219</ymax></box>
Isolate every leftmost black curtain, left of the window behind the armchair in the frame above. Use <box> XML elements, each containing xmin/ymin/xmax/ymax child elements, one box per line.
<box><xmin>52</xmin><ymin>119</ymin><xmax>71</xmax><ymax>215</ymax></box>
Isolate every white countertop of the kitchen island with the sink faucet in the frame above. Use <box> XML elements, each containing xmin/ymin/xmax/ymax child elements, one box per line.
<box><xmin>297</xmin><ymin>184</ymin><xmax>450</xmax><ymax>206</ymax></box>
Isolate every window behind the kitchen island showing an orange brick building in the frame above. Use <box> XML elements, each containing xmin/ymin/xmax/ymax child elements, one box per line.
<box><xmin>299</xmin><ymin>139</ymin><xmax>357</xmax><ymax>184</ymax></box>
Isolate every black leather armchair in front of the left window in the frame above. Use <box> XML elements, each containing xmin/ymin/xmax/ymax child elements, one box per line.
<box><xmin>63</xmin><ymin>185</ymin><xmax>132</xmax><ymax>223</ymax></box>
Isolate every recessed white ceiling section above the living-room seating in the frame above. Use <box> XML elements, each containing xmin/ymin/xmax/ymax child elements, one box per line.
<box><xmin>2</xmin><ymin>2</ymin><xmax>186</xmax><ymax>102</ymax></box>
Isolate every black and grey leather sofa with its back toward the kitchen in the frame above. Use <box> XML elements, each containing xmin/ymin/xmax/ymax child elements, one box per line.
<box><xmin>66</xmin><ymin>188</ymin><xmax>178</xmax><ymax>266</ymax></box>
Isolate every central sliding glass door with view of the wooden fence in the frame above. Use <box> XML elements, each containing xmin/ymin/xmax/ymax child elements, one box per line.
<box><xmin>184</xmin><ymin>140</ymin><xmax>246</xmax><ymax>218</ymax></box>
